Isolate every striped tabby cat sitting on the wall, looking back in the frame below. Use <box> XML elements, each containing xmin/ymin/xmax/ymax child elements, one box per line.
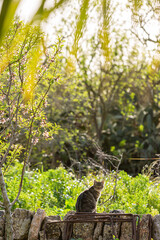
<box><xmin>76</xmin><ymin>180</ymin><xmax>104</xmax><ymax>213</ymax></box>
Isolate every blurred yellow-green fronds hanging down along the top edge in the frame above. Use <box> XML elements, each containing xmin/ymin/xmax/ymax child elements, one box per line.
<box><xmin>0</xmin><ymin>0</ymin><xmax>159</xmax><ymax>75</ymax></box>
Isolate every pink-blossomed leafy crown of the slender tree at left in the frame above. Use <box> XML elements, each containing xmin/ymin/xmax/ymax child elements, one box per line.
<box><xmin>0</xmin><ymin>19</ymin><xmax>60</xmax><ymax>164</ymax></box>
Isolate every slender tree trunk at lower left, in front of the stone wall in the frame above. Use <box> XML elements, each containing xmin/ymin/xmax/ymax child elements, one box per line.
<box><xmin>0</xmin><ymin>167</ymin><xmax>13</xmax><ymax>240</ymax></box>
